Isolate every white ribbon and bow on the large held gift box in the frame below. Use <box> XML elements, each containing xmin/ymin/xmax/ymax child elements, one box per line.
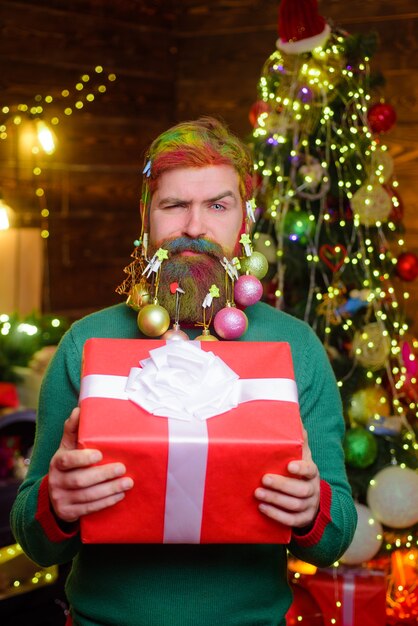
<box><xmin>80</xmin><ymin>341</ymin><xmax>298</xmax><ymax>543</ymax></box>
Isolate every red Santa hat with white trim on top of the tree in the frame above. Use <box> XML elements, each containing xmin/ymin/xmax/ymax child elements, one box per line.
<box><xmin>276</xmin><ymin>0</ymin><xmax>331</xmax><ymax>54</ymax></box>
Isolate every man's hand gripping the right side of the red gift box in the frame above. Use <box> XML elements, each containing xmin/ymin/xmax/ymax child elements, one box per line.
<box><xmin>255</xmin><ymin>430</ymin><xmax>320</xmax><ymax>528</ymax></box>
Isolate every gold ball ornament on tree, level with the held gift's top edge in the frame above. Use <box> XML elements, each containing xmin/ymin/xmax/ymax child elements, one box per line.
<box><xmin>351</xmin><ymin>322</ymin><xmax>390</xmax><ymax>370</ymax></box>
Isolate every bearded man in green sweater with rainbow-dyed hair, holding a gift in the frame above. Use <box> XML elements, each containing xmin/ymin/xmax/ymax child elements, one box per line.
<box><xmin>12</xmin><ymin>118</ymin><xmax>356</xmax><ymax>626</ymax></box>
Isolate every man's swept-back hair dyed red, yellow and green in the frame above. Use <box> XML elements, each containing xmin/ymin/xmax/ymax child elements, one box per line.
<box><xmin>142</xmin><ymin>117</ymin><xmax>253</xmax><ymax>224</ymax></box>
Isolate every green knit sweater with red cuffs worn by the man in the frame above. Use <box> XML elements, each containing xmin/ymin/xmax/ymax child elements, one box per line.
<box><xmin>11</xmin><ymin>303</ymin><xmax>356</xmax><ymax>626</ymax></box>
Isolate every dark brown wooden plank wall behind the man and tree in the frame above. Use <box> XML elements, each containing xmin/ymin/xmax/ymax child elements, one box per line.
<box><xmin>0</xmin><ymin>0</ymin><xmax>418</xmax><ymax>326</ymax></box>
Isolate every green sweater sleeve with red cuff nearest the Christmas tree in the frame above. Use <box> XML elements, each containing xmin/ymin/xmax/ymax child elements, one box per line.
<box><xmin>289</xmin><ymin>329</ymin><xmax>357</xmax><ymax>567</ymax></box>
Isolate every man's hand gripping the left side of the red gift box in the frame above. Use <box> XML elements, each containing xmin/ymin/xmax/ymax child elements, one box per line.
<box><xmin>48</xmin><ymin>409</ymin><xmax>133</xmax><ymax>522</ymax></box>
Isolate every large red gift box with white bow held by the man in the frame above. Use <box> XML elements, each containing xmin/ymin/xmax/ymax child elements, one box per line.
<box><xmin>79</xmin><ymin>339</ymin><xmax>303</xmax><ymax>543</ymax></box>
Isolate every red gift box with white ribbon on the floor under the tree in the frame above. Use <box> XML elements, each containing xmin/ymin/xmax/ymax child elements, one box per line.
<box><xmin>292</xmin><ymin>566</ymin><xmax>386</xmax><ymax>626</ymax></box>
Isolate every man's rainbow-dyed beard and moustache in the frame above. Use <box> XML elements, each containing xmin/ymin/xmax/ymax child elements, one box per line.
<box><xmin>149</xmin><ymin>237</ymin><xmax>226</xmax><ymax>324</ymax></box>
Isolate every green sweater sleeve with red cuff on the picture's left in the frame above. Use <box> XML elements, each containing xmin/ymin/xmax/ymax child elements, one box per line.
<box><xmin>10</xmin><ymin>331</ymin><xmax>81</xmax><ymax>567</ymax></box>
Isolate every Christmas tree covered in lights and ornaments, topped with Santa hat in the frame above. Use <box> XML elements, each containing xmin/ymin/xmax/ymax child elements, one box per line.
<box><xmin>250</xmin><ymin>0</ymin><xmax>418</xmax><ymax>623</ymax></box>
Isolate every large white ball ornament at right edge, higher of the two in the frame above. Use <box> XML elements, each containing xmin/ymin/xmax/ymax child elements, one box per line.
<box><xmin>367</xmin><ymin>465</ymin><xmax>418</xmax><ymax>528</ymax></box>
